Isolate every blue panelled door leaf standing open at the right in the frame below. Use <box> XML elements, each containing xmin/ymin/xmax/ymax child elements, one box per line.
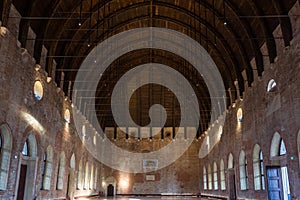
<box><xmin>267</xmin><ymin>167</ymin><xmax>283</xmax><ymax>200</ymax></box>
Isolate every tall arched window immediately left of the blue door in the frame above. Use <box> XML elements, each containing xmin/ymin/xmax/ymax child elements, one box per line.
<box><xmin>253</xmin><ymin>144</ymin><xmax>265</xmax><ymax>190</ymax></box>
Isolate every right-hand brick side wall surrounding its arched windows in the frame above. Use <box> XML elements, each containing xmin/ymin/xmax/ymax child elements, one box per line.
<box><xmin>199</xmin><ymin>2</ymin><xmax>300</xmax><ymax>199</ymax></box>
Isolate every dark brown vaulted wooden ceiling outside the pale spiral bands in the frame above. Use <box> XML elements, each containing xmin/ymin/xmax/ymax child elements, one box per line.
<box><xmin>0</xmin><ymin>0</ymin><xmax>296</xmax><ymax>132</ymax></box>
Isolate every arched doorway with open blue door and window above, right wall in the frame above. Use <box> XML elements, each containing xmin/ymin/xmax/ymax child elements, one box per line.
<box><xmin>267</xmin><ymin>132</ymin><xmax>290</xmax><ymax>200</ymax></box>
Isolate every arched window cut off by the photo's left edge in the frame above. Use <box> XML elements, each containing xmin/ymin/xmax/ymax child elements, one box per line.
<box><xmin>0</xmin><ymin>124</ymin><xmax>12</xmax><ymax>190</ymax></box>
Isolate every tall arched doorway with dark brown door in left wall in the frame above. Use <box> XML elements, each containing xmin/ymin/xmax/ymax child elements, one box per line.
<box><xmin>17</xmin><ymin>134</ymin><xmax>38</xmax><ymax>199</ymax></box>
